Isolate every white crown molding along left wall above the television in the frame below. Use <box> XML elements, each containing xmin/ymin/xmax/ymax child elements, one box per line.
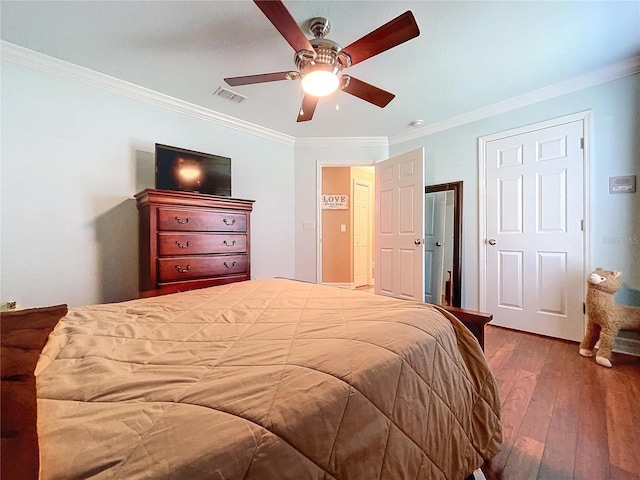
<box><xmin>0</xmin><ymin>40</ymin><xmax>295</xmax><ymax>146</ymax></box>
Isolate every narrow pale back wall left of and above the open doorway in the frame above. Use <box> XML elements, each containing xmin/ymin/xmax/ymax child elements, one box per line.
<box><xmin>295</xmin><ymin>138</ymin><xmax>389</xmax><ymax>282</ymax></box>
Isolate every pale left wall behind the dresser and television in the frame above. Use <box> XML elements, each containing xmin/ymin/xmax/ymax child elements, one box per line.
<box><xmin>0</xmin><ymin>61</ymin><xmax>294</xmax><ymax>308</ymax></box>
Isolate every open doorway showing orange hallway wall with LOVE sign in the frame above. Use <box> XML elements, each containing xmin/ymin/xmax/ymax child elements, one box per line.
<box><xmin>317</xmin><ymin>165</ymin><xmax>375</xmax><ymax>289</ymax></box>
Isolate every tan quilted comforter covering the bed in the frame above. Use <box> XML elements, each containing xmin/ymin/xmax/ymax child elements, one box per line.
<box><xmin>36</xmin><ymin>279</ymin><xmax>501</xmax><ymax>480</ymax></box>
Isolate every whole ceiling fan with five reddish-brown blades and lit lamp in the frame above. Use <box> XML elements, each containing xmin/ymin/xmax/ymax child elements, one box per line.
<box><xmin>224</xmin><ymin>0</ymin><xmax>420</xmax><ymax>122</ymax></box>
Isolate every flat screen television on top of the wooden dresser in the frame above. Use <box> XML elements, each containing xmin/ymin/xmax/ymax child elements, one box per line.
<box><xmin>156</xmin><ymin>143</ymin><xmax>231</xmax><ymax>197</ymax></box>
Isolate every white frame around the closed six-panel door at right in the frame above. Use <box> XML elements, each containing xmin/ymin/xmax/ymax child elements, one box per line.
<box><xmin>478</xmin><ymin>110</ymin><xmax>593</xmax><ymax>311</ymax></box>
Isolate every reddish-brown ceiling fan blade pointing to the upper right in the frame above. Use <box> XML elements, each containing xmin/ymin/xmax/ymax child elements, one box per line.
<box><xmin>342</xmin><ymin>10</ymin><xmax>420</xmax><ymax>65</ymax></box>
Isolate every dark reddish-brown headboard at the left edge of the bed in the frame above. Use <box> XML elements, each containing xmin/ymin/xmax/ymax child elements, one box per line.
<box><xmin>0</xmin><ymin>305</ymin><xmax>67</xmax><ymax>480</ymax></box>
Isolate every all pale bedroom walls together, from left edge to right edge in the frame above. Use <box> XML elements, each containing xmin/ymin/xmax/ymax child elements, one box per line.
<box><xmin>0</xmin><ymin>50</ymin><xmax>640</xmax><ymax>318</ymax></box>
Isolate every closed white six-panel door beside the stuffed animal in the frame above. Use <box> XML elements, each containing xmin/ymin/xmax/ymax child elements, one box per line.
<box><xmin>484</xmin><ymin>120</ymin><xmax>584</xmax><ymax>340</ymax></box>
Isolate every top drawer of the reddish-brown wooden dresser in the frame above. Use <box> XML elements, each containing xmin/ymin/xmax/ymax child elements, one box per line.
<box><xmin>158</xmin><ymin>208</ymin><xmax>247</xmax><ymax>232</ymax></box>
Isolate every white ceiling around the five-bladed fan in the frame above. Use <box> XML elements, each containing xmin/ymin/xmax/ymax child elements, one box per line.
<box><xmin>0</xmin><ymin>0</ymin><xmax>640</xmax><ymax>137</ymax></box>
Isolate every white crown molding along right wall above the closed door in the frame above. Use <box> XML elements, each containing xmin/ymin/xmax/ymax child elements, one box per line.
<box><xmin>389</xmin><ymin>56</ymin><xmax>640</xmax><ymax>145</ymax></box>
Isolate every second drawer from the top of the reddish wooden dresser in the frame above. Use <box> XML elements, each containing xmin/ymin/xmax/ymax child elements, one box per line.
<box><xmin>158</xmin><ymin>233</ymin><xmax>247</xmax><ymax>257</ymax></box>
